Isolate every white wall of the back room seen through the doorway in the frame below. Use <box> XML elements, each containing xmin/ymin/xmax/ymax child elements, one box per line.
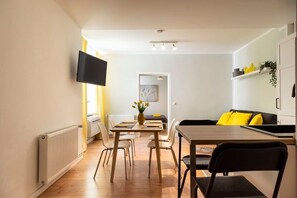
<box><xmin>140</xmin><ymin>75</ymin><xmax>168</xmax><ymax>116</ymax></box>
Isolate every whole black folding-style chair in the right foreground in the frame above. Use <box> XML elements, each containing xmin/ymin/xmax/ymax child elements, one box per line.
<box><xmin>195</xmin><ymin>142</ymin><xmax>288</xmax><ymax>198</ymax></box>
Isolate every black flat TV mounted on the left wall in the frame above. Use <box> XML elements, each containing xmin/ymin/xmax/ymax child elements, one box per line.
<box><xmin>76</xmin><ymin>51</ymin><xmax>107</xmax><ymax>86</ymax></box>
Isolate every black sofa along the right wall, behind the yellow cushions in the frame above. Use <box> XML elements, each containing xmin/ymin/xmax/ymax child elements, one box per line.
<box><xmin>180</xmin><ymin>109</ymin><xmax>277</xmax><ymax>125</ymax></box>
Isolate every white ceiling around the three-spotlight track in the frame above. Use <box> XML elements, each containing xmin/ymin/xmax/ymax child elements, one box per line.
<box><xmin>56</xmin><ymin>0</ymin><xmax>296</xmax><ymax>54</ymax></box>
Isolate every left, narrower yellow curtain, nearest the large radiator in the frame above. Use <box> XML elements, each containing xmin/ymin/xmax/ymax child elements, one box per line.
<box><xmin>81</xmin><ymin>37</ymin><xmax>88</xmax><ymax>151</ymax></box>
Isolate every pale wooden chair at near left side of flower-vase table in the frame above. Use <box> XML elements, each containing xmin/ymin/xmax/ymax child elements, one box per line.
<box><xmin>93</xmin><ymin>122</ymin><xmax>131</xmax><ymax>179</ymax></box>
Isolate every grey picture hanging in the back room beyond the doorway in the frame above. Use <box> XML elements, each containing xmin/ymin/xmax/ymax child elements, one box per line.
<box><xmin>139</xmin><ymin>85</ymin><xmax>158</xmax><ymax>102</ymax></box>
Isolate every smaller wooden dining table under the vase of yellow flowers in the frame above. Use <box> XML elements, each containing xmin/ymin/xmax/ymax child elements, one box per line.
<box><xmin>110</xmin><ymin>120</ymin><xmax>163</xmax><ymax>183</ymax></box>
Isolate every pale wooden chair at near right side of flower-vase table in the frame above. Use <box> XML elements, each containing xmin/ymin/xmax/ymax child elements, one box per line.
<box><xmin>147</xmin><ymin>121</ymin><xmax>179</xmax><ymax>178</ymax></box>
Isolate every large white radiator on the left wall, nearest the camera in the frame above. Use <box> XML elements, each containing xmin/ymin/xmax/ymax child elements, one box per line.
<box><xmin>39</xmin><ymin>126</ymin><xmax>78</xmax><ymax>184</ymax></box>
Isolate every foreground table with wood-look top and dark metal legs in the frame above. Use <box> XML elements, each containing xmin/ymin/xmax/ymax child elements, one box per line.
<box><xmin>176</xmin><ymin>125</ymin><xmax>296</xmax><ymax>198</ymax></box>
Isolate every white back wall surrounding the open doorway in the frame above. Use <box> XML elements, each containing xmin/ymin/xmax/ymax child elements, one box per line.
<box><xmin>105</xmin><ymin>54</ymin><xmax>232</xmax><ymax>120</ymax></box>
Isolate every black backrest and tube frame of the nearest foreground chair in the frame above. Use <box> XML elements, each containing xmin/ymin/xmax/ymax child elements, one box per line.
<box><xmin>208</xmin><ymin>142</ymin><xmax>288</xmax><ymax>197</ymax></box>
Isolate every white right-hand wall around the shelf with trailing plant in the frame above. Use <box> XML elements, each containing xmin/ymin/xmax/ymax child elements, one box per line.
<box><xmin>233</xmin><ymin>29</ymin><xmax>286</xmax><ymax>113</ymax></box>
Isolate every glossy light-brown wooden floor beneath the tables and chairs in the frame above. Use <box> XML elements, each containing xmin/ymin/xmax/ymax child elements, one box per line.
<box><xmin>40</xmin><ymin>133</ymin><xmax>203</xmax><ymax>198</ymax></box>
